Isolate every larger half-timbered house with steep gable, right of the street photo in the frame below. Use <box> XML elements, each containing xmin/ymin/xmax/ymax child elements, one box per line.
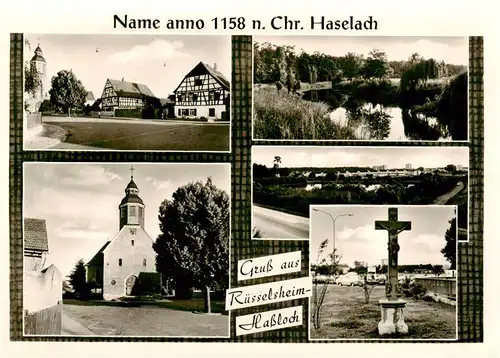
<box><xmin>174</xmin><ymin>62</ymin><xmax>230</xmax><ymax>120</ymax></box>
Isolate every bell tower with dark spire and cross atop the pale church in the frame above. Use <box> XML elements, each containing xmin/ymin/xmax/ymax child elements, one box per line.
<box><xmin>119</xmin><ymin>166</ymin><xmax>145</xmax><ymax>230</ymax></box>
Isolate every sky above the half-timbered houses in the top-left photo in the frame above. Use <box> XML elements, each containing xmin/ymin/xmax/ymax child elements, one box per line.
<box><xmin>25</xmin><ymin>34</ymin><xmax>231</xmax><ymax>99</ymax></box>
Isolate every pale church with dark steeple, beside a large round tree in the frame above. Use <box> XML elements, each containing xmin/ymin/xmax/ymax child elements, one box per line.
<box><xmin>86</xmin><ymin>167</ymin><xmax>156</xmax><ymax>300</ymax></box>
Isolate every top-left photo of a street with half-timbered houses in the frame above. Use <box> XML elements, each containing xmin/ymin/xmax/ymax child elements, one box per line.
<box><xmin>23</xmin><ymin>34</ymin><xmax>231</xmax><ymax>152</ymax></box>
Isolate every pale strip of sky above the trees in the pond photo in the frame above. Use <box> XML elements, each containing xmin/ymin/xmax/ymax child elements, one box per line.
<box><xmin>254</xmin><ymin>36</ymin><xmax>469</xmax><ymax>66</ymax></box>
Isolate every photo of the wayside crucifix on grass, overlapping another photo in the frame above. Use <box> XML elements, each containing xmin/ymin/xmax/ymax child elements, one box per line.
<box><xmin>309</xmin><ymin>205</ymin><xmax>458</xmax><ymax>340</ymax></box>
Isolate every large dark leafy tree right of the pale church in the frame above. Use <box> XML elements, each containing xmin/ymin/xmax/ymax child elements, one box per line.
<box><xmin>153</xmin><ymin>178</ymin><xmax>229</xmax><ymax>313</ymax></box>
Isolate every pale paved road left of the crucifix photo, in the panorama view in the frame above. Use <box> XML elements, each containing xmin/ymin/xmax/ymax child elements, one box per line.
<box><xmin>252</xmin><ymin>205</ymin><xmax>309</xmax><ymax>239</ymax></box>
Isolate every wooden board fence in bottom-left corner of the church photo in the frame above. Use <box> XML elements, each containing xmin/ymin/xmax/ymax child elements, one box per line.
<box><xmin>24</xmin><ymin>301</ymin><xmax>62</xmax><ymax>335</ymax></box>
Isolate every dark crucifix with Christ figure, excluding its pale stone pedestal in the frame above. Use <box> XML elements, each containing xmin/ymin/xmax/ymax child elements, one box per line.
<box><xmin>375</xmin><ymin>208</ymin><xmax>411</xmax><ymax>301</ymax></box>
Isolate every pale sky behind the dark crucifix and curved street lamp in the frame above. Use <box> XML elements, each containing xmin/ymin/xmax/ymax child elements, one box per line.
<box><xmin>310</xmin><ymin>205</ymin><xmax>456</xmax><ymax>266</ymax></box>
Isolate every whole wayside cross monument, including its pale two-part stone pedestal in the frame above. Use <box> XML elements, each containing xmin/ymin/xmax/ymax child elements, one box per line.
<box><xmin>375</xmin><ymin>208</ymin><xmax>411</xmax><ymax>335</ymax></box>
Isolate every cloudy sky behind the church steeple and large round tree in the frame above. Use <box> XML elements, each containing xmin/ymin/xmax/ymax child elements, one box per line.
<box><xmin>23</xmin><ymin>162</ymin><xmax>231</xmax><ymax>275</ymax></box>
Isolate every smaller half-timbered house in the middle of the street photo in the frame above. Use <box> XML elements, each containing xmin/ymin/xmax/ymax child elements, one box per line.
<box><xmin>101</xmin><ymin>78</ymin><xmax>157</xmax><ymax>111</ymax></box>
